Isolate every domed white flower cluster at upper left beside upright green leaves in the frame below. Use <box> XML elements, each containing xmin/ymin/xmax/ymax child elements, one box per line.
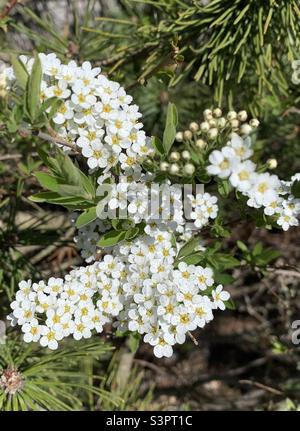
<box><xmin>6</xmin><ymin>53</ymin><xmax>151</xmax><ymax>176</ymax></box>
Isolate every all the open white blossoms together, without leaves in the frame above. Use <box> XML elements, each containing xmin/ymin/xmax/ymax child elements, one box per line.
<box><xmin>5</xmin><ymin>54</ymin><xmax>300</xmax><ymax>358</ymax></box>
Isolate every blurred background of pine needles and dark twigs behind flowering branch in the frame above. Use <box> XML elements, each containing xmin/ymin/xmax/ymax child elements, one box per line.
<box><xmin>0</xmin><ymin>0</ymin><xmax>300</xmax><ymax>410</ymax></box>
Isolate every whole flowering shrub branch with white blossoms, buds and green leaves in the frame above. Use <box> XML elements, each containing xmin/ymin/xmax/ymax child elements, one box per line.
<box><xmin>5</xmin><ymin>54</ymin><xmax>300</xmax><ymax>357</ymax></box>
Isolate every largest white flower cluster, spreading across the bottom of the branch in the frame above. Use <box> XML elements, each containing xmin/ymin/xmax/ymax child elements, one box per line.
<box><xmin>9</xmin><ymin>229</ymin><xmax>230</xmax><ymax>358</ymax></box>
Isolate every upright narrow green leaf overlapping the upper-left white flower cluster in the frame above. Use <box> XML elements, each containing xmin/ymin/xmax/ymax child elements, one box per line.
<box><xmin>26</xmin><ymin>54</ymin><xmax>42</xmax><ymax>121</ymax></box>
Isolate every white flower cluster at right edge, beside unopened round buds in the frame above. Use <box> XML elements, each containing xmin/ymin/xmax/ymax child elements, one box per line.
<box><xmin>207</xmin><ymin>134</ymin><xmax>300</xmax><ymax>230</ymax></box>
